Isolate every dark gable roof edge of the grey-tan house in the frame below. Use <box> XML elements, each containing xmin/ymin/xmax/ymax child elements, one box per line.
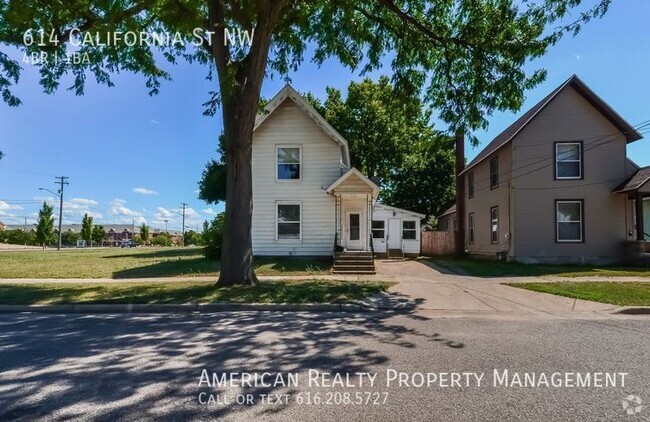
<box><xmin>461</xmin><ymin>75</ymin><xmax>643</xmax><ymax>174</ymax></box>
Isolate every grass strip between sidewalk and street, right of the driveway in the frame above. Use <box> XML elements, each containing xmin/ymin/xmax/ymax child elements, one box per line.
<box><xmin>508</xmin><ymin>282</ymin><xmax>650</xmax><ymax>306</ymax></box>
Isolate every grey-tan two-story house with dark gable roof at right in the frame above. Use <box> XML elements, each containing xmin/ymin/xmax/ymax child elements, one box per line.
<box><xmin>440</xmin><ymin>75</ymin><xmax>650</xmax><ymax>263</ymax></box>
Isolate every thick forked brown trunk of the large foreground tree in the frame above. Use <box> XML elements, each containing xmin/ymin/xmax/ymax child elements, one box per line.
<box><xmin>209</xmin><ymin>1</ymin><xmax>284</xmax><ymax>286</ymax></box>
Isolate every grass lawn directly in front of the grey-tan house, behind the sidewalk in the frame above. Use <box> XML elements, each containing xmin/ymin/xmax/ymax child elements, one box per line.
<box><xmin>426</xmin><ymin>257</ymin><xmax>650</xmax><ymax>277</ymax></box>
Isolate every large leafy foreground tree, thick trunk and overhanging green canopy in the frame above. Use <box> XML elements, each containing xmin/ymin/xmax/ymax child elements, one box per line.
<box><xmin>0</xmin><ymin>0</ymin><xmax>611</xmax><ymax>285</ymax></box>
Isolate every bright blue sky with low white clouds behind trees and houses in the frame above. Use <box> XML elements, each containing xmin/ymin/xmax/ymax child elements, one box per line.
<box><xmin>0</xmin><ymin>1</ymin><xmax>650</xmax><ymax>230</ymax></box>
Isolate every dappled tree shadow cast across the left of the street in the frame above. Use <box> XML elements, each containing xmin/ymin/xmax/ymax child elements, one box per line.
<box><xmin>0</xmin><ymin>312</ymin><xmax>465</xmax><ymax>420</ymax></box>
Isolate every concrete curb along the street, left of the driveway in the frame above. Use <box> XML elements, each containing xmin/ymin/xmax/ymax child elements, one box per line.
<box><xmin>0</xmin><ymin>303</ymin><xmax>379</xmax><ymax>314</ymax></box>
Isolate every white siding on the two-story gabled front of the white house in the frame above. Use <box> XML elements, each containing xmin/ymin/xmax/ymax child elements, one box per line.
<box><xmin>253</xmin><ymin>99</ymin><xmax>342</xmax><ymax>256</ymax></box>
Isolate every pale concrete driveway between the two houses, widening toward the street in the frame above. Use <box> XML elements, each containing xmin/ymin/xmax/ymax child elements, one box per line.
<box><xmin>375</xmin><ymin>260</ymin><xmax>619</xmax><ymax>319</ymax></box>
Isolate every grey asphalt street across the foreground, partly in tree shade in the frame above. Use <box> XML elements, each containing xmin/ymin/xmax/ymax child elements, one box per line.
<box><xmin>0</xmin><ymin>312</ymin><xmax>650</xmax><ymax>422</ymax></box>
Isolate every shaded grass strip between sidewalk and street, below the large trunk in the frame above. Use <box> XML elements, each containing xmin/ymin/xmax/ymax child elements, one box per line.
<box><xmin>0</xmin><ymin>280</ymin><xmax>391</xmax><ymax>305</ymax></box>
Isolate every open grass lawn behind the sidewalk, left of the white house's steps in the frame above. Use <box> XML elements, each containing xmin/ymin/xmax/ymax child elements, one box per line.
<box><xmin>0</xmin><ymin>248</ymin><xmax>331</xmax><ymax>279</ymax></box>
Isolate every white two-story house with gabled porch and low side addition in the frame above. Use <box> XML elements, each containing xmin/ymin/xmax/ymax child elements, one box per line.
<box><xmin>247</xmin><ymin>85</ymin><xmax>424</xmax><ymax>270</ymax></box>
